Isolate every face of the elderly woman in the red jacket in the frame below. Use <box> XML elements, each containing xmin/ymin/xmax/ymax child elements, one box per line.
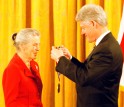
<box><xmin>21</xmin><ymin>36</ymin><xmax>40</xmax><ymax>60</ymax></box>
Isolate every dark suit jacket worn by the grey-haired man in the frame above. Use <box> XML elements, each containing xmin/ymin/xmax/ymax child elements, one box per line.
<box><xmin>56</xmin><ymin>32</ymin><xmax>123</xmax><ymax>107</ymax></box>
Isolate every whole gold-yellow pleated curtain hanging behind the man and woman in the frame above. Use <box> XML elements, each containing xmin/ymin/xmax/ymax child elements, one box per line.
<box><xmin>0</xmin><ymin>0</ymin><xmax>124</xmax><ymax>107</ymax></box>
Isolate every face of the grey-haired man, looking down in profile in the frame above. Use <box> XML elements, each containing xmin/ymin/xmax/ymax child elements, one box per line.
<box><xmin>80</xmin><ymin>21</ymin><xmax>97</xmax><ymax>43</ymax></box>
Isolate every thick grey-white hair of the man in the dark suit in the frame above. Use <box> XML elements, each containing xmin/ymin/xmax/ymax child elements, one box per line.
<box><xmin>75</xmin><ymin>4</ymin><xmax>108</xmax><ymax>26</ymax></box>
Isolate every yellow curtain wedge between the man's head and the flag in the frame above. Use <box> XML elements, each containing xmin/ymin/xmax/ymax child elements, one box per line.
<box><xmin>104</xmin><ymin>0</ymin><xmax>122</xmax><ymax>39</ymax></box>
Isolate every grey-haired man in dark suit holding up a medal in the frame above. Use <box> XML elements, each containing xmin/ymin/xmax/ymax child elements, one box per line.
<box><xmin>51</xmin><ymin>4</ymin><xmax>123</xmax><ymax>107</ymax></box>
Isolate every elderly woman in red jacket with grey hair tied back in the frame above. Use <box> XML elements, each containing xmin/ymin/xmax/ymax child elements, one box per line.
<box><xmin>2</xmin><ymin>28</ymin><xmax>43</xmax><ymax>107</ymax></box>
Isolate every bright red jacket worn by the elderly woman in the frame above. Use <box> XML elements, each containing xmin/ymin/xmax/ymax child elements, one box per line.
<box><xmin>2</xmin><ymin>54</ymin><xmax>43</xmax><ymax>107</ymax></box>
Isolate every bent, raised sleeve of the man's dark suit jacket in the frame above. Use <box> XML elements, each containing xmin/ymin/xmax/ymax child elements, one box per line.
<box><xmin>56</xmin><ymin>51</ymin><xmax>113</xmax><ymax>85</ymax></box>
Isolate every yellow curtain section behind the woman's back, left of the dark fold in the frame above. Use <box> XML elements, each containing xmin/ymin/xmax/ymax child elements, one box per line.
<box><xmin>0</xmin><ymin>0</ymin><xmax>25</xmax><ymax>107</ymax></box>
